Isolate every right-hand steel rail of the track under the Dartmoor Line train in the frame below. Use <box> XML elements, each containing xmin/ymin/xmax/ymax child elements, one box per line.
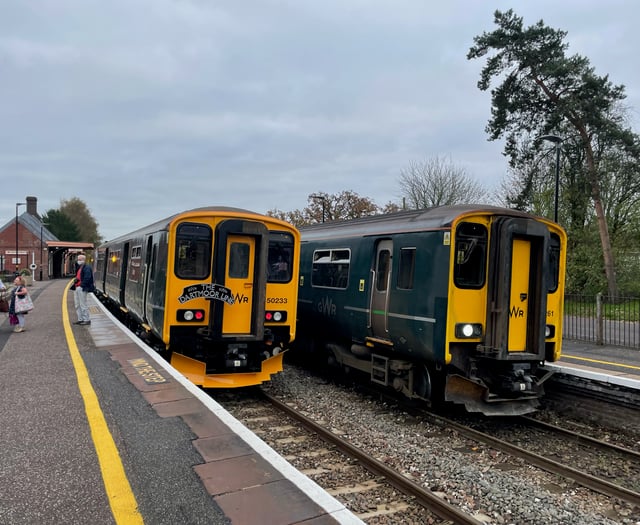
<box><xmin>262</xmin><ymin>391</ymin><xmax>482</xmax><ymax>525</ymax></box>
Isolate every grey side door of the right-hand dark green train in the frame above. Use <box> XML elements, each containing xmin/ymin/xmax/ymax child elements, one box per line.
<box><xmin>370</xmin><ymin>239</ymin><xmax>393</xmax><ymax>339</ymax></box>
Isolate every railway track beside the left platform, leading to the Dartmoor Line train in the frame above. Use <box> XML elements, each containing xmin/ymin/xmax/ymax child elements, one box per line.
<box><xmin>218</xmin><ymin>391</ymin><xmax>483</xmax><ymax>525</ymax></box>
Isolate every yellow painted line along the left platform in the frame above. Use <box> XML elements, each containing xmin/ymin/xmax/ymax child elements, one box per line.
<box><xmin>62</xmin><ymin>287</ymin><xmax>144</xmax><ymax>525</ymax></box>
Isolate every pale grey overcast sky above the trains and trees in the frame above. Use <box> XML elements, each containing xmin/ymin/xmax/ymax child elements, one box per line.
<box><xmin>0</xmin><ymin>0</ymin><xmax>640</xmax><ymax>239</ymax></box>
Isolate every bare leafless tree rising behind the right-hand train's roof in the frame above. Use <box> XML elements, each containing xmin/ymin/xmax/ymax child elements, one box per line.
<box><xmin>399</xmin><ymin>157</ymin><xmax>488</xmax><ymax>209</ymax></box>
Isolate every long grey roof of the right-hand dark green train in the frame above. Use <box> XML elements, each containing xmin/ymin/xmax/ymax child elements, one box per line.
<box><xmin>300</xmin><ymin>204</ymin><xmax>544</xmax><ymax>242</ymax></box>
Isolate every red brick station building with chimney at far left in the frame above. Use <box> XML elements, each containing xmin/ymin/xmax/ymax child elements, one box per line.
<box><xmin>0</xmin><ymin>197</ymin><xmax>93</xmax><ymax>281</ymax></box>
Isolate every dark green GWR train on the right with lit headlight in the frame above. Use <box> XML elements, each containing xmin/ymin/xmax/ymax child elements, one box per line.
<box><xmin>298</xmin><ymin>205</ymin><xmax>566</xmax><ymax>415</ymax></box>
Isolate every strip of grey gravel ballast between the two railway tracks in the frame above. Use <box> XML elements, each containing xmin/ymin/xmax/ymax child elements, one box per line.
<box><xmin>265</xmin><ymin>365</ymin><xmax>640</xmax><ymax>525</ymax></box>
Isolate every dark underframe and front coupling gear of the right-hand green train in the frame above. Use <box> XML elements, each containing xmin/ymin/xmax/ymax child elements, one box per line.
<box><xmin>325</xmin><ymin>341</ymin><xmax>551</xmax><ymax>416</ymax></box>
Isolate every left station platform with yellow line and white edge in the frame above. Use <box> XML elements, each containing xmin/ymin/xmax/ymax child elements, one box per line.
<box><xmin>0</xmin><ymin>280</ymin><xmax>363</xmax><ymax>525</ymax></box>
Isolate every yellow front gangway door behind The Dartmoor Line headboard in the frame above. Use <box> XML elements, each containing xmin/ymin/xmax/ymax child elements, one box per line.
<box><xmin>222</xmin><ymin>235</ymin><xmax>255</xmax><ymax>334</ymax></box>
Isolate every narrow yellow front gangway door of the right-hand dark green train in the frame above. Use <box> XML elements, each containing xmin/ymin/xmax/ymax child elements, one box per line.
<box><xmin>509</xmin><ymin>239</ymin><xmax>531</xmax><ymax>352</ymax></box>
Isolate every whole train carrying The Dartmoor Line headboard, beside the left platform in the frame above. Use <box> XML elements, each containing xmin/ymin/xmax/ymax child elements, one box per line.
<box><xmin>95</xmin><ymin>207</ymin><xmax>300</xmax><ymax>388</ymax></box>
